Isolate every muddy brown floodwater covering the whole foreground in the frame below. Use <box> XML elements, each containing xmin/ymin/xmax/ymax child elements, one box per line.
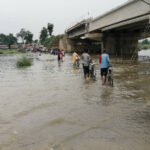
<box><xmin>0</xmin><ymin>54</ymin><xmax>150</xmax><ymax>150</ymax></box>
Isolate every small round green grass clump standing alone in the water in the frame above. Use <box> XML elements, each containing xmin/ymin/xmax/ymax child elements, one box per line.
<box><xmin>16</xmin><ymin>56</ymin><xmax>32</xmax><ymax>68</ymax></box>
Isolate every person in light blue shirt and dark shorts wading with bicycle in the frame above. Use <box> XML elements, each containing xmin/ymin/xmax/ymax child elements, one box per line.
<box><xmin>99</xmin><ymin>50</ymin><xmax>110</xmax><ymax>85</ymax></box>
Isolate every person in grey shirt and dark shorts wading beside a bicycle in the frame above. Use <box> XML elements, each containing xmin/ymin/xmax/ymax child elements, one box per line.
<box><xmin>82</xmin><ymin>50</ymin><xmax>91</xmax><ymax>80</ymax></box>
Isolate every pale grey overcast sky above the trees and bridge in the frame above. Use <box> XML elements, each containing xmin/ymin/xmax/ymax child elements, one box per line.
<box><xmin>0</xmin><ymin>0</ymin><xmax>128</xmax><ymax>39</ymax></box>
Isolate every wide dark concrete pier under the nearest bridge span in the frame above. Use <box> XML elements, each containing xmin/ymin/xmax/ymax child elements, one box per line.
<box><xmin>103</xmin><ymin>32</ymin><xmax>139</xmax><ymax>58</ymax></box>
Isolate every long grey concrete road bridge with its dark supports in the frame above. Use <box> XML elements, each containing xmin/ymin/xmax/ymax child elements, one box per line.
<box><xmin>61</xmin><ymin>0</ymin><xmax>150</xmax><ymax>57</ymax></box>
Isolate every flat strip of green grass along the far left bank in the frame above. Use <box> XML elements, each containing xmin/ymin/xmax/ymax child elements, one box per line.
<box><xmin>0</xmin><ymin>49</ymin><xmax>26</xmax><ymax>55</ymax></box>
